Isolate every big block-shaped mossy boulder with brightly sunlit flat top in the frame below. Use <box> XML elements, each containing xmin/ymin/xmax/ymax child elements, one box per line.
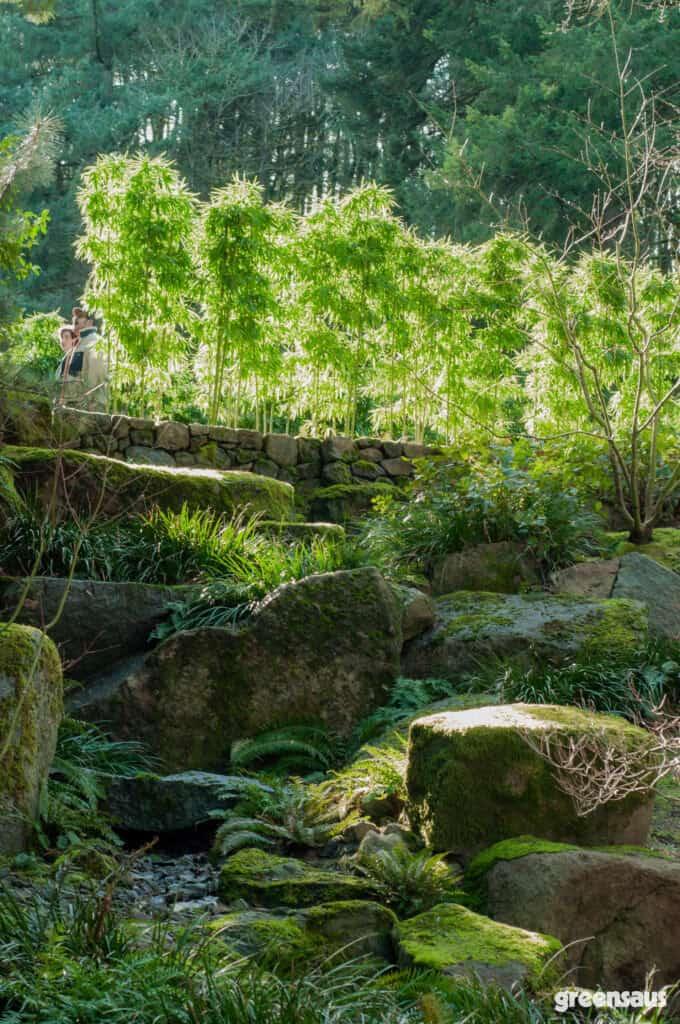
<box><xmin>407</xmin><ymin>703</ymin><xmax>653</xmax><ymax>859</ymax></box>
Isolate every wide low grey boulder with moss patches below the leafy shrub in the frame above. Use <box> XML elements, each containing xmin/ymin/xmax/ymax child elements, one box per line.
<box><xmin>402</xmin><ymin>591</ymin><xmax>648</xmax><ymax>681</ymax></box>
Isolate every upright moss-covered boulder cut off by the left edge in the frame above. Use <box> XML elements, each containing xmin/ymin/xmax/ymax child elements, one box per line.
<box><xmin>0</xmin><ymin>623</ymin><xmax>63</xmax><ymax>853</ymax></box>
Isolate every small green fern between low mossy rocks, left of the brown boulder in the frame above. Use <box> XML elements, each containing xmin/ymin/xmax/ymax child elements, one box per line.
<box><xmin>357</xmin><ymin>846</ymin><xmax>461</xmax><ymax>918</ymax></box>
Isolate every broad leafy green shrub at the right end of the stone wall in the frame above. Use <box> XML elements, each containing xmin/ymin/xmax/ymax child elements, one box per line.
<box><xmin>364</xmin><ymin>449</ymin><xmax>601</xmax><ymax>578</ymax></box>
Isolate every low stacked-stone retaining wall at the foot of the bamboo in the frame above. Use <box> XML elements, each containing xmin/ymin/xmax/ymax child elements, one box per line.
<box><xmin>54</xmin><ymin>408</ymin><xmax>440</xmax><ymax>498</ymax></box>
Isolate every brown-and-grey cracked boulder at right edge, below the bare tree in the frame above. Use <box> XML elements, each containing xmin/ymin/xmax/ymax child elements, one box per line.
<box><xmin>553</xmin><ymin>549</ymin><xmax>680</xmax><ymax>640</ymax></box>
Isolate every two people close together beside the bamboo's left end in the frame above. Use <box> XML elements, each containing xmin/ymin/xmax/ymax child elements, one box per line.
<box><xmin>56</xmin><ymin>306</ymin><xmax>109</xmax><ymax>413</ymax></box>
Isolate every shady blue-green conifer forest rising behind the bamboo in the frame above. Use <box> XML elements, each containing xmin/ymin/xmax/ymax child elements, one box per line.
<box><xmin>0</xmin><ymin>0</ymin><xmax>680</xmax><ymax>310</ymax></box>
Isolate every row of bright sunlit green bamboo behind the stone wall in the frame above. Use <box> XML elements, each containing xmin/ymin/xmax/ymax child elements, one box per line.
<box><xmin>77</xmin><ymin>156</ymin><xmax>680</xmax><ymax>512</ymax></box>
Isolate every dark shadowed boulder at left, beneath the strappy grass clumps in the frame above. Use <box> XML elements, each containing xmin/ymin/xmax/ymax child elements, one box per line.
<box><xmin>0</xmin><ymin>577</ymin><xmax>201</xmax><ymax>679</ymax></box>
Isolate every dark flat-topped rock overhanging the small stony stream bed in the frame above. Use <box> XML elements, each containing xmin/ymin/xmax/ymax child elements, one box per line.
<box><xmin>105</xmin><ymin>771</ymin><xmax>266</xmax><ymax>833</ymax></box>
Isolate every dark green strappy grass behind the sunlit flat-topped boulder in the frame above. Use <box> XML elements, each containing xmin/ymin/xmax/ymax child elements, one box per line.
<box><xmin>500</xmin><ymin>644</ymin><xmax>680</xmax><ymax>721</ymax></box>
